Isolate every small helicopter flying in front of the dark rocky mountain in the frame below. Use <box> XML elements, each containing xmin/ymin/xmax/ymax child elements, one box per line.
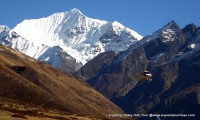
<box><xmin>136</xmin><ymin>70</ymin><xmax>152</xmax><ymax>82</ymax></box>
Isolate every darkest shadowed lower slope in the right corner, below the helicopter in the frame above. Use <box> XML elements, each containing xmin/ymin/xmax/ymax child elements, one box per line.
<box><xmin>114</xmin><ymin>51</ymin><xmax>200</xmax><ymax>116</ymax></box>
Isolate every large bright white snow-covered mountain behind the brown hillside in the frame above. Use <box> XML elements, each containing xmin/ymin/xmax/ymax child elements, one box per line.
<box><xmin>1</xmin><ymin>9</ymin><xmax>142</xmax><ymax>72</ymax></box>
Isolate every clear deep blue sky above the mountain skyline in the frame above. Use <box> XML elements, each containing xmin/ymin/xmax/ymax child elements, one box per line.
<box><xmin>0</xmin><ymin>0</ymin><xmax>200</xmax><ymax>36</ymax></box>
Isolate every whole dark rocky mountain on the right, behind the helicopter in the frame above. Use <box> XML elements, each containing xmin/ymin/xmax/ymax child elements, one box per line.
<box><xmin>76</xmin><ymin>21</ymin><xmax>200</xmax><ymax>118</ymax></box>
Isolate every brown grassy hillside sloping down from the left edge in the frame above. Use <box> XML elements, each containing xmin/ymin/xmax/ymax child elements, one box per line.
<box><xmin>0</xmin><ymin>45</ymin><xmax>127</xmax><ymax>120</ymax></box>
